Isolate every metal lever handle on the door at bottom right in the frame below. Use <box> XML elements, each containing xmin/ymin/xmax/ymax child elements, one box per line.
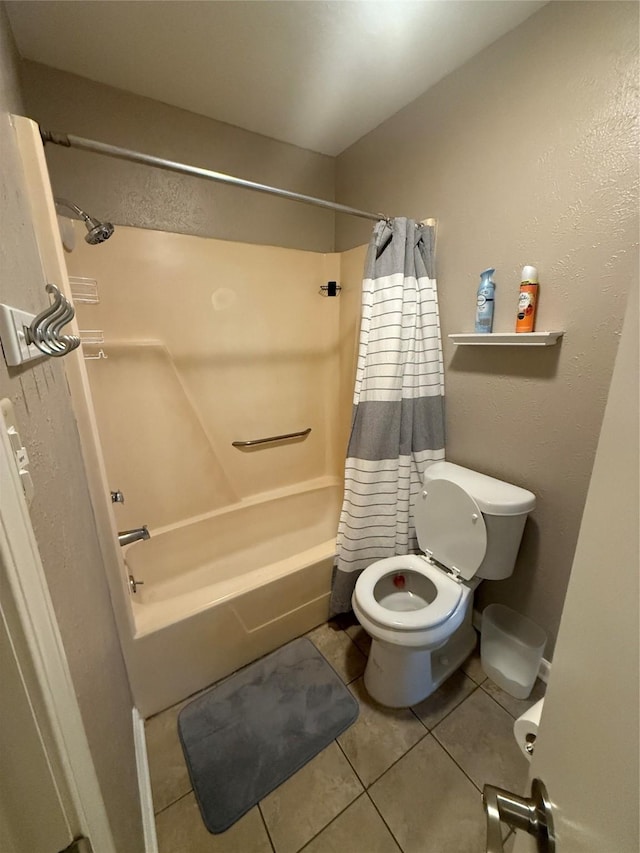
<box><xmin>482</xmin><ymin>779</ymin><xmax>556</xmax><ymax>853</ymax></box>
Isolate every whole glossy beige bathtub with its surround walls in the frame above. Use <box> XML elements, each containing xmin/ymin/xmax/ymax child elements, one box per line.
<box><xmin>65</xmin><ymin>223</ymin><xmax>362</xmax><ymax>716</ymax></box>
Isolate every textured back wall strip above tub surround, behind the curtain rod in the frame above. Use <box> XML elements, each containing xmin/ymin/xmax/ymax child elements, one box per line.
<box><xmin>22</xmin><ymin>62</ymin><xmax>334</xmax><ymax>252</ymax></box>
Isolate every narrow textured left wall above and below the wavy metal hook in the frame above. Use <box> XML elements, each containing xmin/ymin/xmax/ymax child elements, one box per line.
<box><xmin>0</xmin><ymin>3</ymin><xmax>143</xmax><ymax>853</ymax></box>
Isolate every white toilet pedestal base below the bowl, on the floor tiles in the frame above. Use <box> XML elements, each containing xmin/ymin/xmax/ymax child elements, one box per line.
<box><xmin>364</xmin><ymin>608</ymin><xmax>476</xmax><ymax>708</ymax></box>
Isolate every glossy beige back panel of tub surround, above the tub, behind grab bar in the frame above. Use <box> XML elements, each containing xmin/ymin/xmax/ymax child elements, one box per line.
<box><xmin>66</xmin><ymin>223</ymin><xmax>348</xmax><ymax>528</ymax></box>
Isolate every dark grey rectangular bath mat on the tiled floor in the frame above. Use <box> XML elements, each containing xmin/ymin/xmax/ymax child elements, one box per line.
<box><xmin>178</xmin><ymin>637</ymin><xmax>358</xmax><ymax>833</ymax></box>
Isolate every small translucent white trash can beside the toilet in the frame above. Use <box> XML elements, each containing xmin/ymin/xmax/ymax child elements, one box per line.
<box><xmin>480</xmin><ymin>604</ymin><xmax>547</xmax><ymax>699</ymax></box>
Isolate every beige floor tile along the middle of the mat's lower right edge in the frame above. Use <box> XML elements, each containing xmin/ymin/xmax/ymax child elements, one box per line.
<box><xmin>260</xmin><ymin>742</ymin><xmax>363</xmax><ymax>853</ymax></box>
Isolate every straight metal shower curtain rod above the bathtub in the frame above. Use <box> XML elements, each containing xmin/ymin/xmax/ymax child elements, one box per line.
<box><xmin>40</xmin><ymin>128</ymin><xmax>389</xmax><ymax>222</ymax></box>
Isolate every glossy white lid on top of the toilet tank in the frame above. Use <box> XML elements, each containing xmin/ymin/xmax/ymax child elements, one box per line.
<box><xmin>424</xmin><ymin>461</ymin><xmax>536</xmax><ymax>515</ymax></box>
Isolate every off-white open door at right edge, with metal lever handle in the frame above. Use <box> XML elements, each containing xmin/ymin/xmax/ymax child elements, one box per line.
<box><xmin>504</xmin><ymin>282</ymin><xmax>640</xmax><ymax>853</ymax></box>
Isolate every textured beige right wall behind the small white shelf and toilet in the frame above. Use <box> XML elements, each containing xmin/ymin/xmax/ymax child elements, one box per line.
<box><xmin>336</xmin><ymin>2</ymin><xmax>638</xmax><ymax>657</ymax></box>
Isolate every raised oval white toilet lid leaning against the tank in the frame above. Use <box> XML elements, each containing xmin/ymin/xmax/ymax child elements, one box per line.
<box><xmin>414</xmin><ymin>480</ymin><xmax>487</xmax><ymax>580</ymax></box>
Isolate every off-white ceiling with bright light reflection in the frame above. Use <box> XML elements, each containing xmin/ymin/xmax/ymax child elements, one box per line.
<box><xmin>7</xmin><ymin>0</ymin><xmax>545</xmax><ymax>155</ymax></box>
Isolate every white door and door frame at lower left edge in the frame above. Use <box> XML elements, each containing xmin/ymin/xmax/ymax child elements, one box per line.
<box><xmin>0</xmin><ymin>400</ymin><xmax>116</xmax><ymax>853</ymax></box>
